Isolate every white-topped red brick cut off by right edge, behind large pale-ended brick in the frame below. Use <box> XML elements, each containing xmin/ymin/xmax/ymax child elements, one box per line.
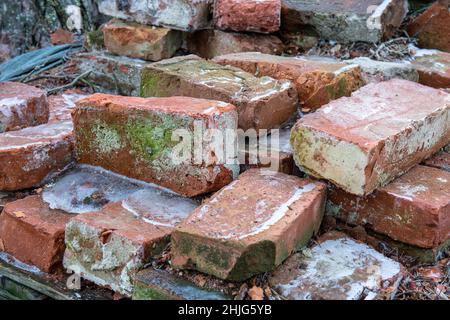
<box><xmin>411</xmin><ymin>49</ymin><xmax>450</xmax><ymax>88</ymax></box>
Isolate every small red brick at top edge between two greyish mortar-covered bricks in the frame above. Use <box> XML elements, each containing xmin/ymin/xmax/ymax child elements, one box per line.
<box><xmin>214</xmin><ymin>0</ymin><xmax>281</xmax><ymax>33</ymax></box>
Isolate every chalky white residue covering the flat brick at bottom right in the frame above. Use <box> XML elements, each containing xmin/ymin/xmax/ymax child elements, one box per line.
<box><xmin>276</xmin><ymin>238</ymin><xmax>401</xmax><ymax>300</ymax></box>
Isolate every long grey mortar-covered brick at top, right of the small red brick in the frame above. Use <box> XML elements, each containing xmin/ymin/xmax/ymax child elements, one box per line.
<box><xmin>281</xmin><ymin>0</ymin><xmax>408</xmax><ymax>42</ymax></box>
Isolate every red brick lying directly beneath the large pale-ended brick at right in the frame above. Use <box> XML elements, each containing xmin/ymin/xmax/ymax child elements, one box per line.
<box><xmin>327</xmin><ymin>166</ymin><xmax>450</xmax><ymax>248</ymax></box>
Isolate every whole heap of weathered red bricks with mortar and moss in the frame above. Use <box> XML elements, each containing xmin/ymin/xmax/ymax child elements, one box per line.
<box><xmin>0</xmin><ymin>0</ymin><xmax>450</xmax><ymax>299</ymax></box>
